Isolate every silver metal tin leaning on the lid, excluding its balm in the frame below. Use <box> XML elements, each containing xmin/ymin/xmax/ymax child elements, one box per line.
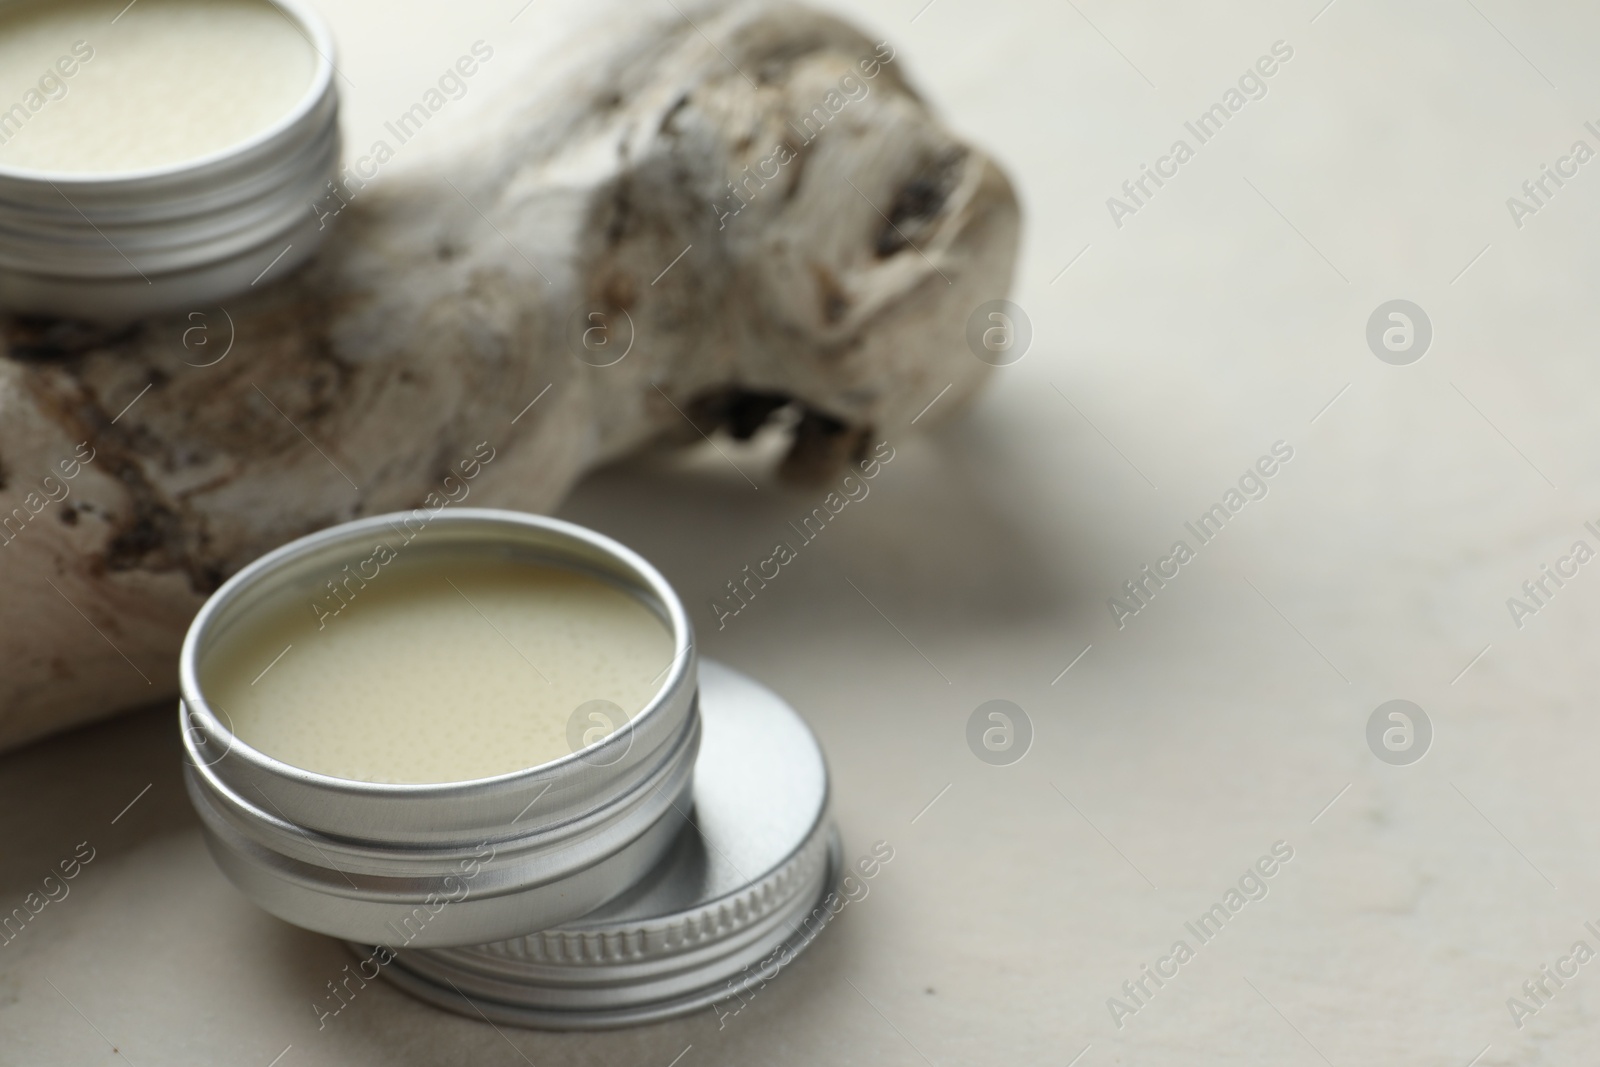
<box><xmin>179</xmin><ymin>509</ymin><xmax>701</xmax><ymax>945</ymax></box>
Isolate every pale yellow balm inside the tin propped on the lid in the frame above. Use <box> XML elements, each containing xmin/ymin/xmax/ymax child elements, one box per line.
<box><xmin>200</xmin><ymin>550</ymin><xmax>674</xmax><ymax>784</ymax></box>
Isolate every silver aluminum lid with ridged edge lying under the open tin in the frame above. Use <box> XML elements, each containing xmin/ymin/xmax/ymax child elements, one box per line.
<box><xmin>363</xmin><ymin>661</ymin><xmax>840</xmax><ymax>1030</ymax></box>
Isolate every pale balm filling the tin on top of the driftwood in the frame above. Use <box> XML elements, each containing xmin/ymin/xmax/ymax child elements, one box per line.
<box><xmin>0</xmin><ymin>0</ymin><xmax>318</xmax><ymax>174</ymax></box>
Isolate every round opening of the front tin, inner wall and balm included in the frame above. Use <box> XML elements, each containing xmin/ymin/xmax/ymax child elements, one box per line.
<box><xmin>194</xmin><ymin>511</ymin><xmax>683</xmax><ymax>785</ymax></box>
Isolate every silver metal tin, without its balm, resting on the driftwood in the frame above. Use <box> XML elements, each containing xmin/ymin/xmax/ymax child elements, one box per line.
<box><xmin>0</xmin><ymin>0</ymin><xmax>341</xmax><ymax>322</ymax></box>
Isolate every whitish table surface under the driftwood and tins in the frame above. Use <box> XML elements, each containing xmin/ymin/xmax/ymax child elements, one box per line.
<box><xmin>0</xmin><ymin>0</ymin><xmax>1600</xmax><ymax>1067</ymax></box>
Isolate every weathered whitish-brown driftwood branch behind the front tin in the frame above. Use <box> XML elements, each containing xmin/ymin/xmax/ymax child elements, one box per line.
<box><xmin>0</xmin><ymin>3</ymin><xmax>1018</xmax><ymax>745</ymax></box>
